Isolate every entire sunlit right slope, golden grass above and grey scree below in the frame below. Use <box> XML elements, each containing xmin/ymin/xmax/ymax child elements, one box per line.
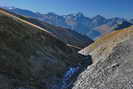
<box><xmin>73</xmin><ymin>26</ymin><xmax>133</xmax><ymax>89</ymax></box>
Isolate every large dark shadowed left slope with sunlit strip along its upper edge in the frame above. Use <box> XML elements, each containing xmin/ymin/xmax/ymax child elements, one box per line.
<box><xmin>0</xmin><ymin>9</ymin><xmax>88</xmax><ymax>89</ymax></box>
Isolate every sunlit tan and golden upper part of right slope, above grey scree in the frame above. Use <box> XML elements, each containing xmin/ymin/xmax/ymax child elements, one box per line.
<box><xmin>79</xmin><ymin>26</ymin><xmax>133</xmax><ymax>62</ymax></box>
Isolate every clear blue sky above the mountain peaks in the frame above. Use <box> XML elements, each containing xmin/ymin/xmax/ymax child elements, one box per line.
<box><xmin>0</xmin><ymin>0</ymin><xmax>133</xmax><ymax>19</ymax></box>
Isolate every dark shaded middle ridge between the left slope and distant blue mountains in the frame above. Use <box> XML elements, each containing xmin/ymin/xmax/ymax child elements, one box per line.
<box><xmin>24</xmin><ymin>18</ymin><xmax>93</xmax><ymax>50</ymax></box>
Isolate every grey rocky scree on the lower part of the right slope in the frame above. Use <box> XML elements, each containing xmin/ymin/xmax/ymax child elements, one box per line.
<box><xmin>72</xmin><ymin>27</ymin><xmax>133</xmax><ymax>89</ymax></box>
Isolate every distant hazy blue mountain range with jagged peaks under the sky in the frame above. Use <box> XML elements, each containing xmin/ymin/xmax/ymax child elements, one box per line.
<box><xmin>4</xmin><ymin>7</ymin><xmax>133</xmax><ymax>39</ymax></box>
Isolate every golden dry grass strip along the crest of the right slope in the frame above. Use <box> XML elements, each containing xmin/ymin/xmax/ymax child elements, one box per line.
<box><xmin>79</xmin><ymin>26</ymin><xmax>133</xmax><ymax>55</ymax></box>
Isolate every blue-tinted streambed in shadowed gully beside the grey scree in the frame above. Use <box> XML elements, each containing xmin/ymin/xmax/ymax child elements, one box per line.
<box><xmin>61</xmin><ymin>55</ymin><xmax>93</xmax><ymax>89</ymax></box>
